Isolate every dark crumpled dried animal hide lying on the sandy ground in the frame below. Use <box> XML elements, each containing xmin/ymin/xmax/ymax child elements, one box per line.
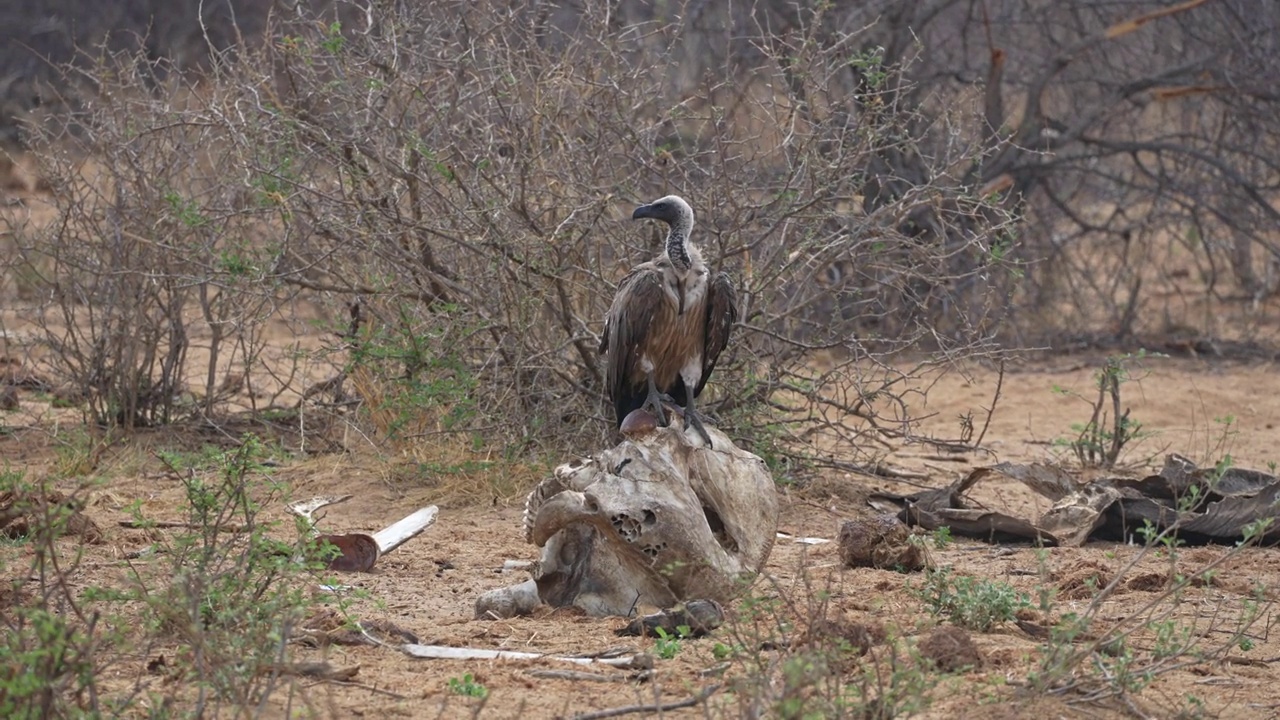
<box><xmin>872</xmin><ymin>455</ymin><xmax>1280</xmax><ymax>546</ymax></box>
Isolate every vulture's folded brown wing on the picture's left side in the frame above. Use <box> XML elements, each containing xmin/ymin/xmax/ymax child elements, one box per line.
<box><xmin>600</xmin><ymin>263</ymin><xmax>663</xmax><ymax>424</ymax></box>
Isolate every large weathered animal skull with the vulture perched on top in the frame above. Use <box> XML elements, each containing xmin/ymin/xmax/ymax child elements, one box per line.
<box><xmin>476</xmin><ymin>411</ymin><xmax>778</xmax><ymax>618</ymax></box>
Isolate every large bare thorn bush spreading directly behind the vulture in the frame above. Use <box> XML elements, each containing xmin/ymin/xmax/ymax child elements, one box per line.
<box><xmin>0</xmin><ymin>3</ymin><xmax>1021</xmax><ymax>464</ymax></box>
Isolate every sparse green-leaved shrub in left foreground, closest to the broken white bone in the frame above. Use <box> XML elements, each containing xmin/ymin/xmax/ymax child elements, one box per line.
<box><xmin>119</xmin><ymin>434</ymin><xmax>322</xmax><ymax>712</ymax></box>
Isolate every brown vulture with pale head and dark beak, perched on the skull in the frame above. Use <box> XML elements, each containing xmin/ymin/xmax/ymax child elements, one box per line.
<box><xmin>600</xmin><ymin>195</ymin><xmax>737</xmax><ymax>447</ymax></box>
